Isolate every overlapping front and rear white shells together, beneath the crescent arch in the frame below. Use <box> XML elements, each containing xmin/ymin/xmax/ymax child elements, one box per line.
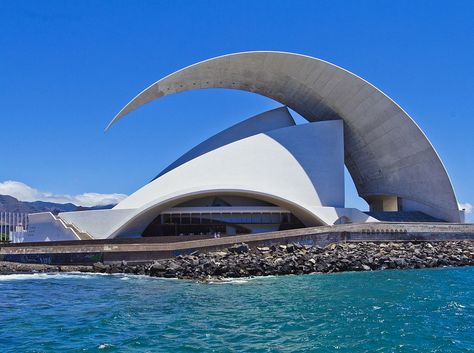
<box><xmin>55</xmin><ymin>108</ymin><xmax>376</xmax><ymax>239</ymax></box>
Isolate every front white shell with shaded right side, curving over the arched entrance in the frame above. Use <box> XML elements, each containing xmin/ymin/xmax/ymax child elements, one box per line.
<box><xmin>110</xmin><ymin>121</ymin><xmax>344</xmax><ymax>237</ymax></box>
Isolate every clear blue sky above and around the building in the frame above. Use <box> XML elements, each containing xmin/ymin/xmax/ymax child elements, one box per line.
<box><xmin>0</xmin><ymin>0</ymin><xmax>474</xmax><ymax>217</ymax></box>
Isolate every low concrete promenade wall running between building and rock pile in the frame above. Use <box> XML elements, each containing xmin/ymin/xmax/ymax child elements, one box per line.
<box><xmin>0</xmin><ymin>223</ymin><xmax>474</xmax><ymax>265</ymax></box>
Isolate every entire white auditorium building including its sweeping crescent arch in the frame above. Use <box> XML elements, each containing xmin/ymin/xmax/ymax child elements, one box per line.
<box><xmin>24</xmin><ymin>52</ymin><xmax>463</xmax><ymax>241</ymax></box>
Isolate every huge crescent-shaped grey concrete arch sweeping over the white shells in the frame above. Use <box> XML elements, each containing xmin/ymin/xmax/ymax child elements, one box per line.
<box><xmin>107</xmin><ymin>51</ymin><xmax>460</xmax><ymax>222</ymax></box>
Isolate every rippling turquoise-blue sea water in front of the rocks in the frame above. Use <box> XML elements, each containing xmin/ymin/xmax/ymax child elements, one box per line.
<box><xmin>0</xmin><ymin>267</ymin><xmax>474</xmax><ymax>352</ymax></box>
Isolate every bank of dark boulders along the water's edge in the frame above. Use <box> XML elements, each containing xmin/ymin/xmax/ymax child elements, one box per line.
<box><xmin>0</xmin><ymin>241</ymin><xmax>474</xmax><ymax>281</ymax></box>
